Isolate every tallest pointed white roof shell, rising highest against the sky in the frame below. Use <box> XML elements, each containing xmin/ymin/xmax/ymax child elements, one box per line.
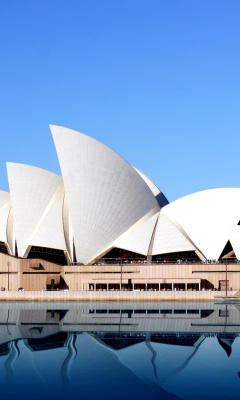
<box><xmin>51</xmin><ymin>126</ymin><xmax>160</xmax><ymax>264</ymax></box>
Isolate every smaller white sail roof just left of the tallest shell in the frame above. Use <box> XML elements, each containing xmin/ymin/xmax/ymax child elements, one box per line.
<box><xmin>7</xmin><ymin>163</ymin><xmax>66</xmax><ymax>257</ymax></box>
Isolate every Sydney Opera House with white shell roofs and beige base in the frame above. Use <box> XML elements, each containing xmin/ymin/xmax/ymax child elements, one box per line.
<box><xmin>0</xmin><ymin>126</ymin><xmax>240</xmax><ymax>291</ymax></box>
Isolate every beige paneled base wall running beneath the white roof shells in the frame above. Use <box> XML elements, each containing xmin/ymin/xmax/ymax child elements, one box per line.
<box><xmin>0</xmin><ymin>253</ymin><xmax>240</xmax><ymax>299</ymax></box>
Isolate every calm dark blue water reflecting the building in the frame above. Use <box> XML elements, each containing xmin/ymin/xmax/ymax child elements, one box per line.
<box><xmin>0</xmin><ymin>302</ymin><xmax>240</xmax><ymax>400</ymax></box>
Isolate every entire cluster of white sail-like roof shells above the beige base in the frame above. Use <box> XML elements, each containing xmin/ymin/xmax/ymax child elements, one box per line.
<box><xmin>0</xmin><ymin>126</ymin><xmax>240</xmax><ymax>264</ymax></box>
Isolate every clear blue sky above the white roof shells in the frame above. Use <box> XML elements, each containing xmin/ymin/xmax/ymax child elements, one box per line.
<box><xmin>0</xmin><ymin>0</ymin><xmax>240</xmax><ymax>201</ymax></box>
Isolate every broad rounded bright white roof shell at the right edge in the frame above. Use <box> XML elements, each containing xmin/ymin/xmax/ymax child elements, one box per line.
<box><xmin>161</xmin><ymin>188</ymin><xmax>240</xmax><ymax>260</ymax></box>
